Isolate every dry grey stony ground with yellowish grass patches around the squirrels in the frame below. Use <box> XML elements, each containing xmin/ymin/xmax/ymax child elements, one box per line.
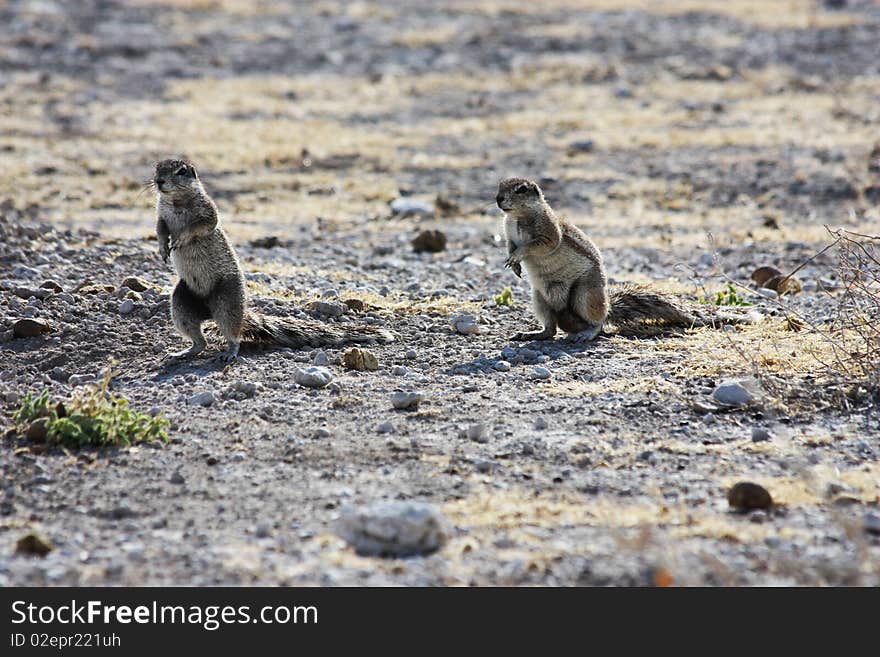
<box><xmin>0</xmin><ymin>0</ymin><xmax>880</xmax><ymax>586</ymax></box>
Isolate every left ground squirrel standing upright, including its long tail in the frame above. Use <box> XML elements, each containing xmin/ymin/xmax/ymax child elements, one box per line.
<box><xmin>153</xmin><ymin>160</ymin><xmax>393</xmax><ymax>362</ymax></box>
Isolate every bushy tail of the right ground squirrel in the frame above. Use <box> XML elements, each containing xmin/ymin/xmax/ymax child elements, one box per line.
<box><xmin>606</xmin><ymin>284</ymin><xmax>760</xmax><ymax>330</ymax></box>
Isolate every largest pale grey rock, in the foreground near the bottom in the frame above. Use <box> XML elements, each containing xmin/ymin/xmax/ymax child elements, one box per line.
<box><xmin>335</xmin><ymin>502</ymin><xmax>451</xmax><ymax>557</ymax></box>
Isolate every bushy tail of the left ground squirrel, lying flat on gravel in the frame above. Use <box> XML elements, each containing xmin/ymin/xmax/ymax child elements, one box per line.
<box><xmin>242</xmin><ymin>311</ymin><xmax>394</xmax><ymax>349</ymax></box>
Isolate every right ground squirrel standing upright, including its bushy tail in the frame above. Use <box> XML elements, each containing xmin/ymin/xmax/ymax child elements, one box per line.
<box><xmin>495</xmin><ymin>178</ymin><xmax>754</xmax><ymax>341</ymax></box>
